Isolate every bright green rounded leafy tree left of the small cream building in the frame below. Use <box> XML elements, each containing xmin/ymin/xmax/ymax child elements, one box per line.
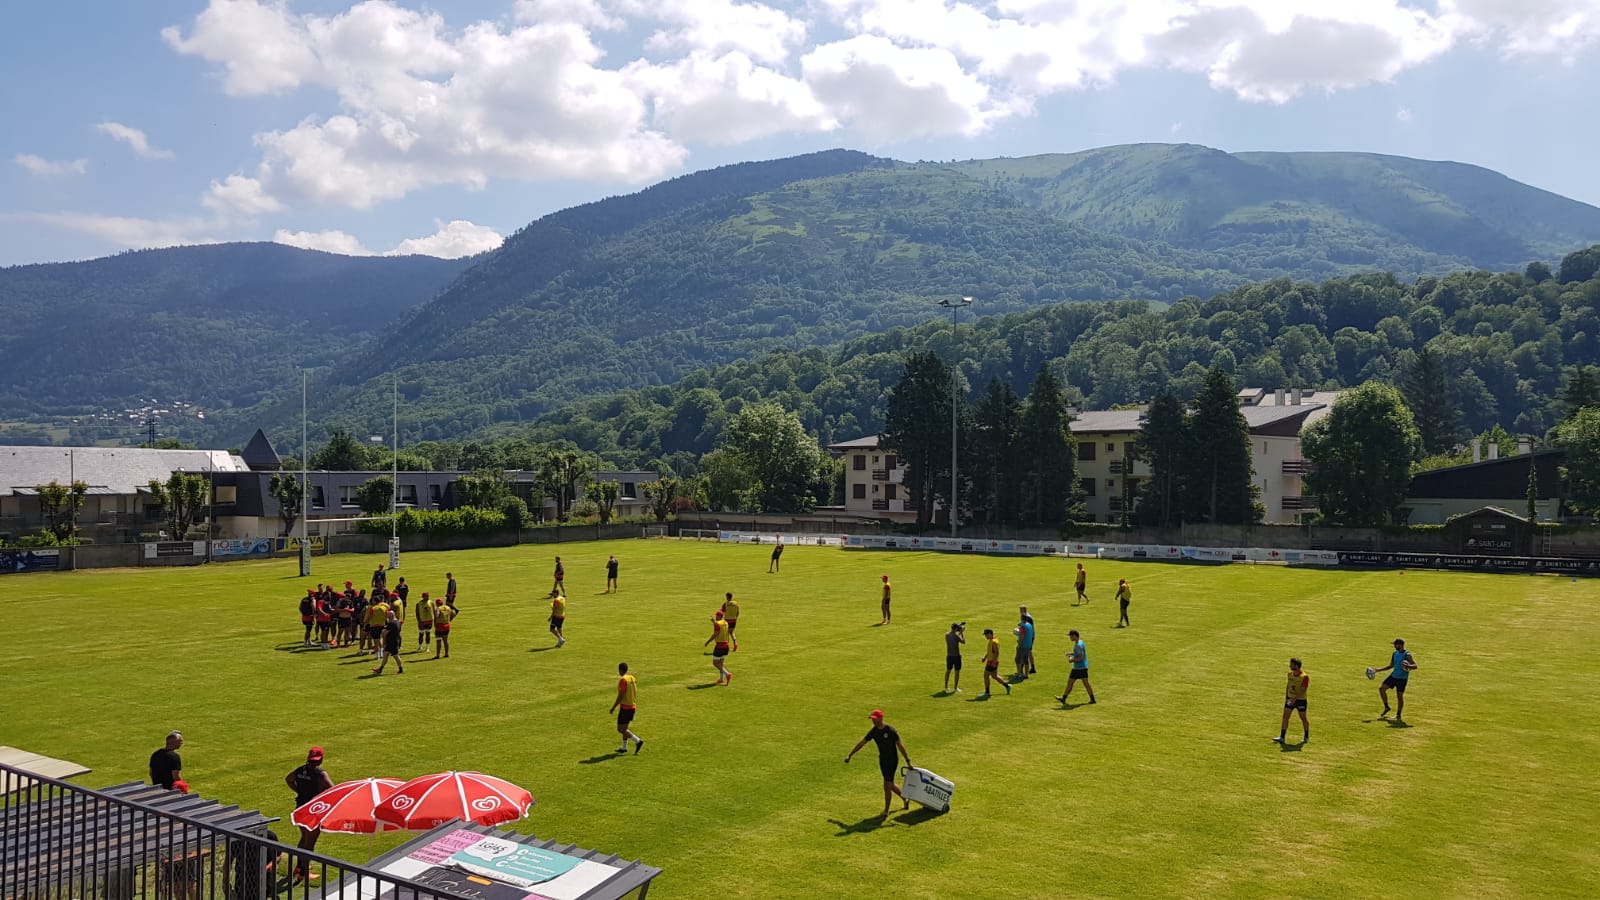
<box><xmin>723</xmin><ymin>402</ymin><xmax>822</xmax><ymax>512</ymax></box>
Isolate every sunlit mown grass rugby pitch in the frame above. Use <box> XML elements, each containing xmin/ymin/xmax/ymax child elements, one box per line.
<box><xmin>0</xmin><ymin>541</ymin><xmax>1600</xmax><ymax>898</ymax></box>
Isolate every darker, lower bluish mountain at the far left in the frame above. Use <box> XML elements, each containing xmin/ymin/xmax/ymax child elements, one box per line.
<box><xmin>0</xmin><ymin>243</ymin><xmax>472</xmax><ymax>418</ymax></box>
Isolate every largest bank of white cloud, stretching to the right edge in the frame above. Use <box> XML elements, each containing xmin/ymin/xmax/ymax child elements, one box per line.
<box><xmin>162</xmin><ymin>0</ymin><xmax>1600</xmax><ymax>215</ymax></box>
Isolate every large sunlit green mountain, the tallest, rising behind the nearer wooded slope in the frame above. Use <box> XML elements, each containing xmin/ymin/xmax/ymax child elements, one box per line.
<box><xmin>281</xmin><ymin>144</ymin><xmax>1600</xmax><ymax>439</ymax></box>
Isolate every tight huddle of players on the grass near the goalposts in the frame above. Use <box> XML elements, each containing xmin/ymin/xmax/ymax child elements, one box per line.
<box><xmin>299</xmin><ymin>565</ymin><xmax>458</xmax><ymax>674</ymax></box>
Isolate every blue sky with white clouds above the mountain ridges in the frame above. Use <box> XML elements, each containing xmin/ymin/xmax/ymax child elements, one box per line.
<box><xmin>0</xmin><ymin>0</ymin><xmax>1600</xmax><ymax>266</ymax></box>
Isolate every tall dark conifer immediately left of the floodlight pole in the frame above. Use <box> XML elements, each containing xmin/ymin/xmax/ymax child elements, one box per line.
<box><xmin>878</xmin><ymin>352</ymin><xmax>955</xmax><ymax>528</ymax></box>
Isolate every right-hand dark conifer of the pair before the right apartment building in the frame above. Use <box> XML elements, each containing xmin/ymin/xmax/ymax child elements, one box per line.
<box><xmin>1181</xmin><ymin>361</ymin><xmax>1261</xmax><ymax>525</ymax></box>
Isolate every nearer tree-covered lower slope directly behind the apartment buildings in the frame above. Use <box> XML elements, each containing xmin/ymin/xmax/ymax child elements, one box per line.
<box><xmin>499</xmin><ymin>247</ymin><xmax>1600</xmax><ymax>474</ymax></box>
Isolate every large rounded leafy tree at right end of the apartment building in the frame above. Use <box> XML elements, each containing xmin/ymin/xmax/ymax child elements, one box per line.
<box><xmin>1301</xmin><ymin>381</ymin><xmax>1422</xmax><ymax>527</ymax></box>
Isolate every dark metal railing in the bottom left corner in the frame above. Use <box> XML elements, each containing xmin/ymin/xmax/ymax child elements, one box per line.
<box><xmin>0</xmin><ymin>765</ymin><xmax>461</xmax><ymax>900</ymax></box>
